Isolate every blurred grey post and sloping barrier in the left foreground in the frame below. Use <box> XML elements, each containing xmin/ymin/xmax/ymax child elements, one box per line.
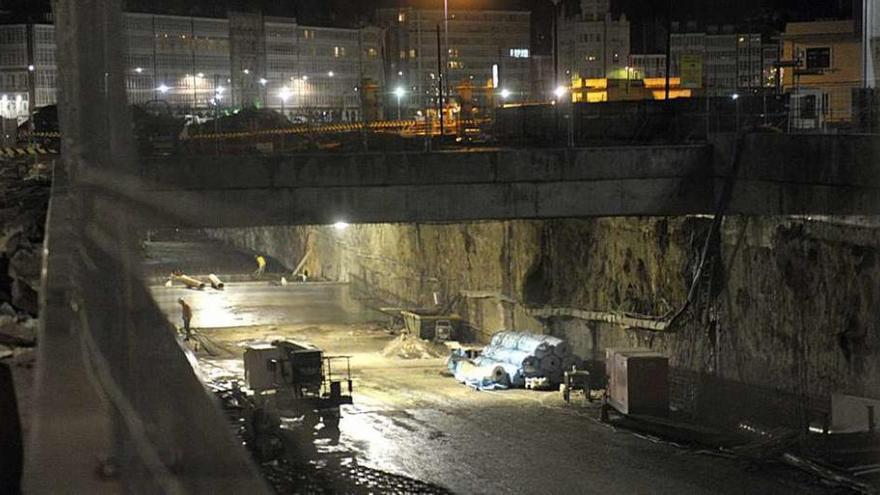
<box><xmin>24</xmin><ymin>0</ymin><xmax>268</xmax><ymax>493</ymax></box>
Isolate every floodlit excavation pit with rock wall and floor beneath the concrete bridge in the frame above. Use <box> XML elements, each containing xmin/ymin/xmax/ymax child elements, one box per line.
<box><xmin>125</xmin><ymin>218</ymin><xmax>876</xmax><ymax>493</ymax></box>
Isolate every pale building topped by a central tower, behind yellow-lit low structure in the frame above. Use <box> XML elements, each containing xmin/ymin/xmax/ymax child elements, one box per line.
<box><xmin>557</xmin><ymin>0</ymin><xmax>630</xmax><ymax>81</ymax></box>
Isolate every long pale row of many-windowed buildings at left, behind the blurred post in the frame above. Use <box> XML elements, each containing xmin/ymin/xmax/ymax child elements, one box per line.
<box><xmin>0</xmin><ymin>12</ymin><xmax>384</xmax><ymax>121</ymax></box>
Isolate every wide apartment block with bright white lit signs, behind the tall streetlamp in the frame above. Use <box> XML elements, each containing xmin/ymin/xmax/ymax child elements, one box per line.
<box><xmin>377</xmin><ymin>7</ymin><xmax>533</xmax><ymax>113</ymax></box>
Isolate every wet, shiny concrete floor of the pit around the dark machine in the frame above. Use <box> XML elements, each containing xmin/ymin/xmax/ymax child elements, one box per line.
<box><xmin>192</xmin><ymin>324</ymin><xmax>828</xmax><ymax>494</ymax></box>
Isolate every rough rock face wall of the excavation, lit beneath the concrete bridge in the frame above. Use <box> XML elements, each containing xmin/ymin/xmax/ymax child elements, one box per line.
<box><xmin>211</xmin><ymin>217</ymin><xmax>880</xmax><ymax>424</ymax></box>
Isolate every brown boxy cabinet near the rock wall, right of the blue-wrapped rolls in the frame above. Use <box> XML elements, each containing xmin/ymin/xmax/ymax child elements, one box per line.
<box><xmin>608</xmin><ymin>351</ymin><xmax>669</xmax><ymax>416</ymax></box>
